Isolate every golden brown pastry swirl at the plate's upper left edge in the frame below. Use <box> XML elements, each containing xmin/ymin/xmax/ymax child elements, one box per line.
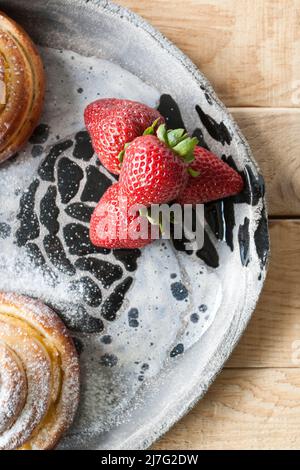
<box><xmin>0</xmin><ymin>12</ymin><xmax>45</xmax><ymax>162</ymax></box>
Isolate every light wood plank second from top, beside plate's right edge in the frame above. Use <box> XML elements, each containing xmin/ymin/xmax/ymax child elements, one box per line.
<box><xmin>230</xmin><ymin>108</ymin><xmax>300</xmax><ymax>216</ymax></box>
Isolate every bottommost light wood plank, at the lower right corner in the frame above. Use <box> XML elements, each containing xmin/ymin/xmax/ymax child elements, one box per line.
<box><xmin>154</xmin><ymin>369</ymin><xmax>300</xmax><ymax>450</ymax></box>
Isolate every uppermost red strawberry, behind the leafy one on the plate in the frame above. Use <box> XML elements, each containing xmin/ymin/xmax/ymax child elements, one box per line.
<box><xmin>84</xmin><ymin>98</ymin><xmax>164</xmax><ymax>174</ymax></box>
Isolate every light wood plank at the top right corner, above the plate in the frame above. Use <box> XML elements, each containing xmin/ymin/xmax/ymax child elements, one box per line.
<box><xmin>118</xmin><ymin>0</ymin><xmax>300</xmax><ymax>107</ymax></box>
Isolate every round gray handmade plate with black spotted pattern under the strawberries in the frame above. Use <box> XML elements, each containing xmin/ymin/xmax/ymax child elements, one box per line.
<box><xmin>0</xmin><ymin>0</ymin><xmax>269</xmax><ymax>449</ymax></box>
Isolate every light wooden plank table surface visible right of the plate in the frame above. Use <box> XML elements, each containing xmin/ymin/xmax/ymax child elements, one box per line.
<box><xmin>117</xmin><ymin>0</ymin><xmax>300</xmax><ymax>450</ymax></box>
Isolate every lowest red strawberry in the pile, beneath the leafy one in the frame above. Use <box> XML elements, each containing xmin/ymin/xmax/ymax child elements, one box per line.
<box><xmin>90</xmin><ymin>183</ymin><xmax>152</xmax><ymax>248</ymax></box>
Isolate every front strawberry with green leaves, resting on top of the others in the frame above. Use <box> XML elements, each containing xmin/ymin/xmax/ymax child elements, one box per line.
<box><xmin>119</xmin><ymin>124</ymin><xmax>198</xmax><ymax>206</ymax></box>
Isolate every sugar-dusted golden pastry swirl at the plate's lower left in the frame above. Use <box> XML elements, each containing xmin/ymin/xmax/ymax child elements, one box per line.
<box><xmin>0</xmin><ymin>293</ymin><xmax>79</xmax><ymax>450</ymax></box>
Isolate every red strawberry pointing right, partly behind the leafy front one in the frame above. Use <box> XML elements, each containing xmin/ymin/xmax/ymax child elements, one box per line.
<box><xmin>177</xmin><ymin>147</ymin><xmax>244</xmax><ymax>204</ymax></box>
